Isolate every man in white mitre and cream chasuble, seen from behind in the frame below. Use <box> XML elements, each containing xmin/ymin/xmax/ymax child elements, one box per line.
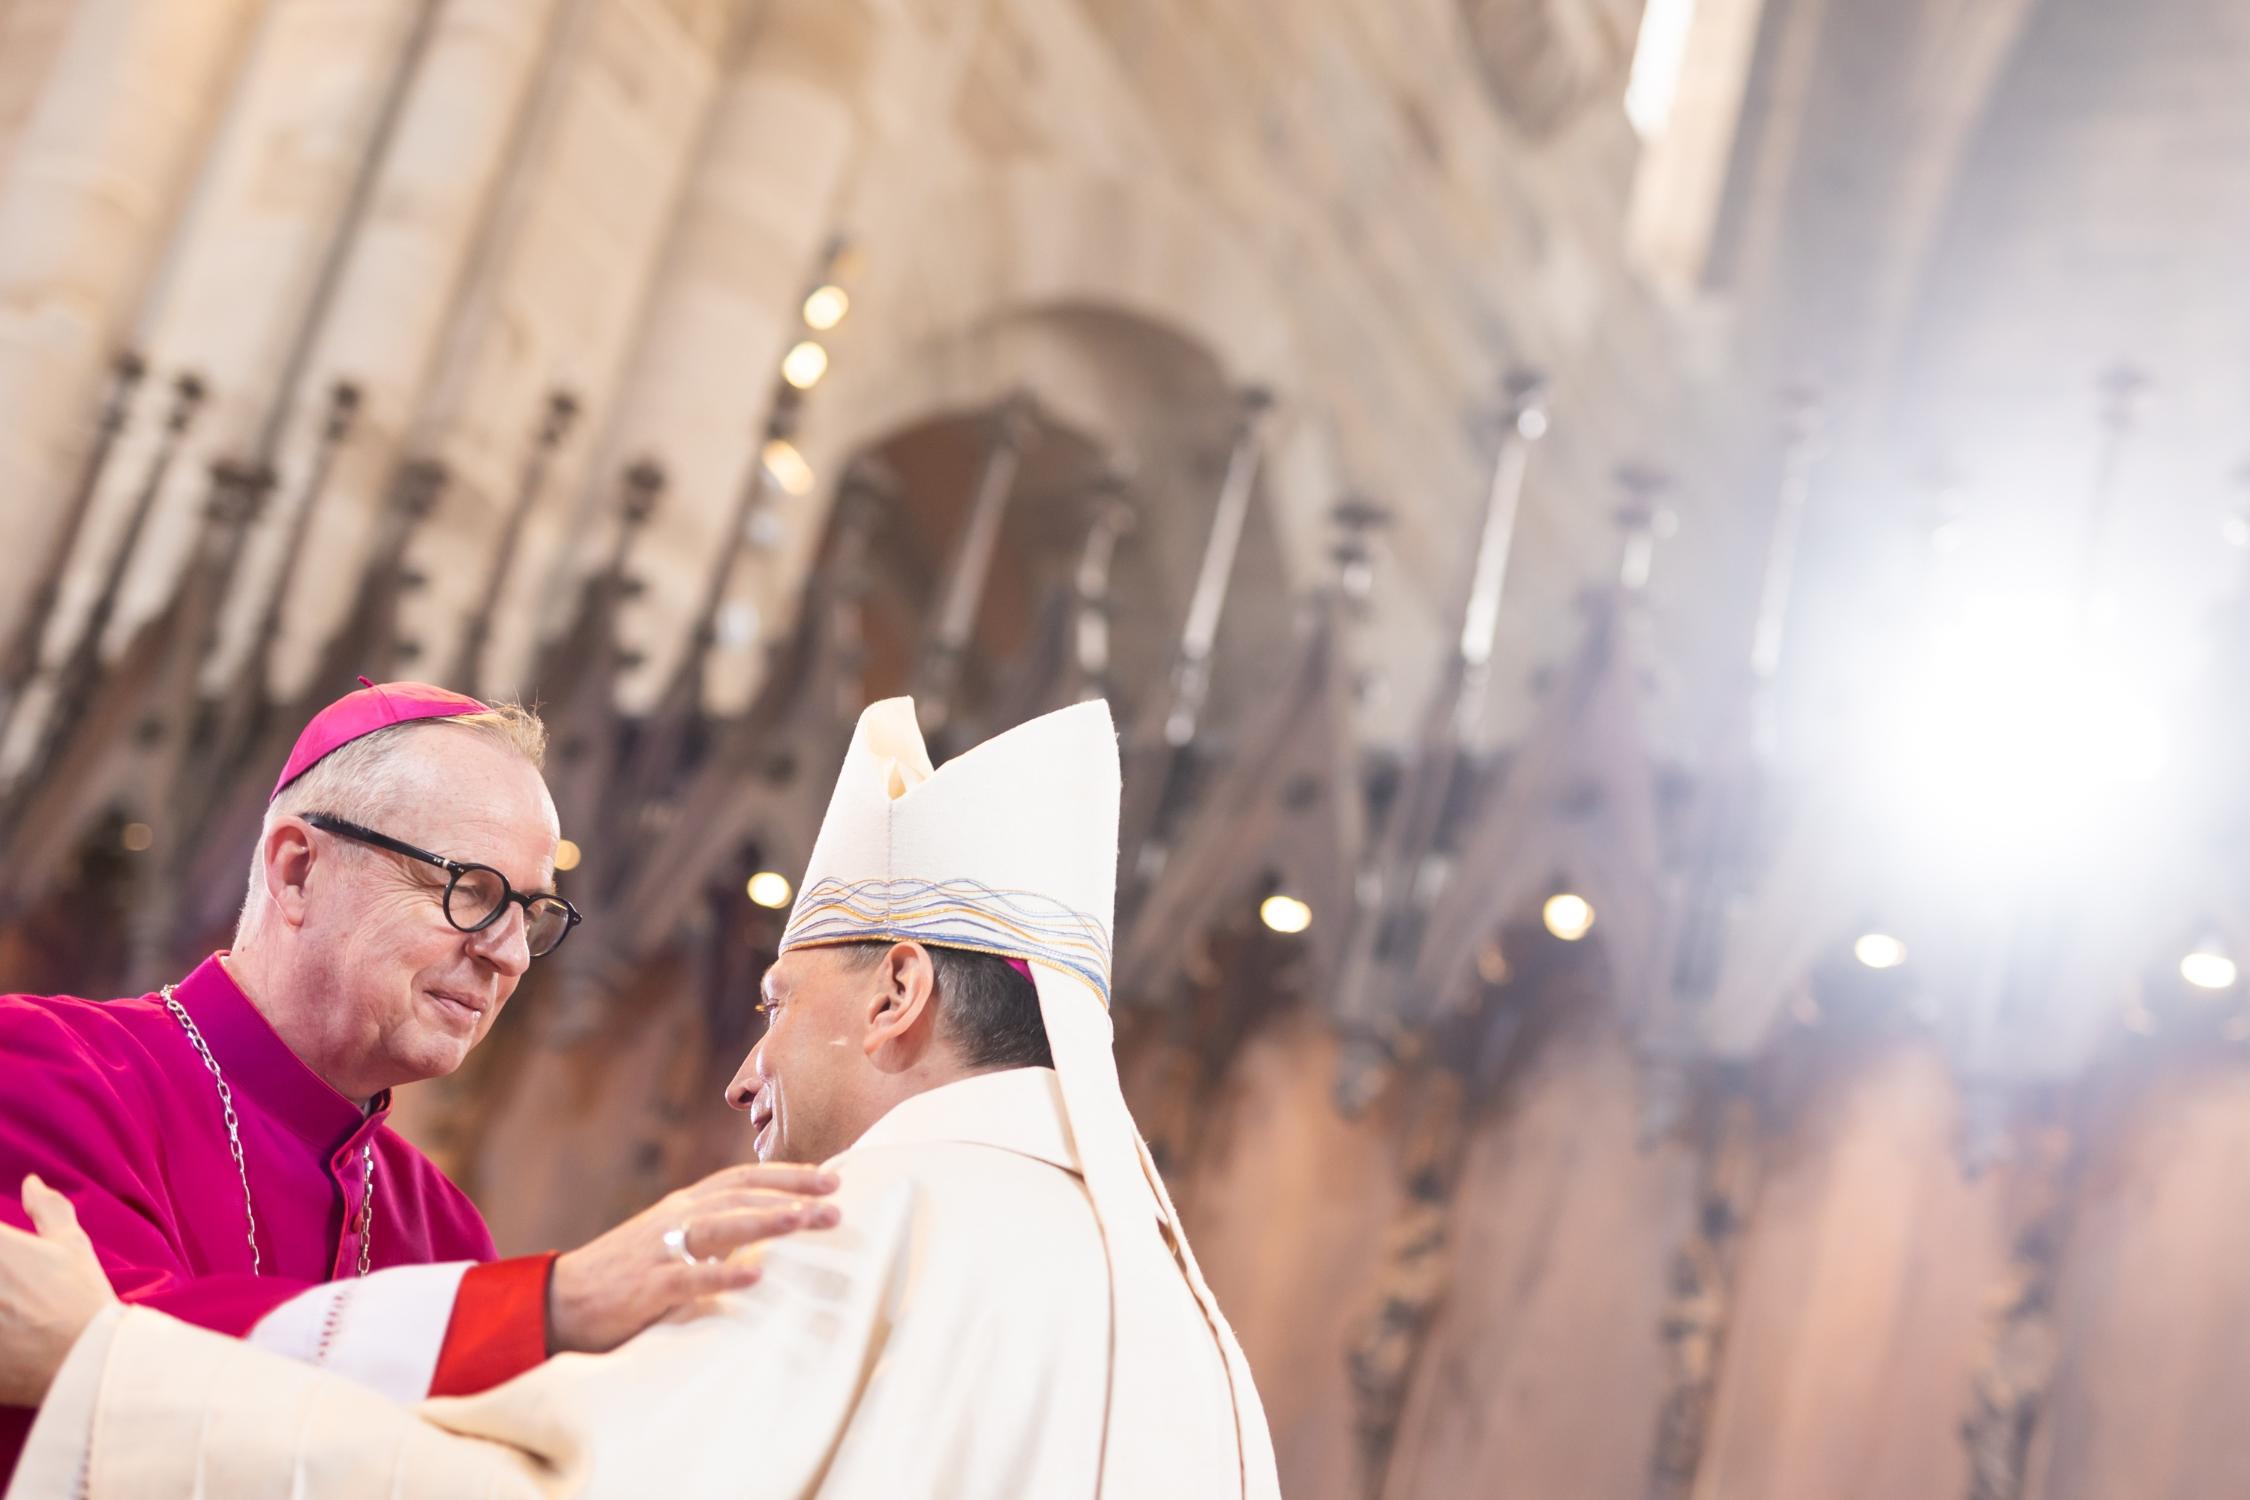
<box><xmin>9</xmin><ymin>699</ymin><xmax>1280</xmax><ymax>1500</ymax></box>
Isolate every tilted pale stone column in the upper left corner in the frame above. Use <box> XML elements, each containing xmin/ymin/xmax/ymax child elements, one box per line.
<box><xmin>0</xmin><ymin>0</ymin><xmax>257</xmax><ymax>652</ymax></box>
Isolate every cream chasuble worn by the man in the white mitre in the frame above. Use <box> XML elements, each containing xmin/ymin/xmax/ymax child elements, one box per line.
<box><xmin>9</xmin><ymin>1068</ymin><xmax>1235</xmax><ymax>1500</ymax></box>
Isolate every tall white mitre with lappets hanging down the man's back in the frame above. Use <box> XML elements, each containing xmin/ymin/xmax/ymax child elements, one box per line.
<box><xmin>781</xmin><ymin>697</ymin><xmax>1276</xmax><ymax>1496</ymax></box>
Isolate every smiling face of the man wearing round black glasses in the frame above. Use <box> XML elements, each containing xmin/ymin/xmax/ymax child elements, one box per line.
<box><xmin>257</xmin><ymin>726</ymin><xmax>558</xmax><ymax>1100</ymax></box>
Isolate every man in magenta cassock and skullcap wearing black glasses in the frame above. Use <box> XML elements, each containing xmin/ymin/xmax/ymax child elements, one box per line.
<box><xmin>0</xmin><ymin>679</ymin><xmax>828</xmax><ymax>1487</ymax></box>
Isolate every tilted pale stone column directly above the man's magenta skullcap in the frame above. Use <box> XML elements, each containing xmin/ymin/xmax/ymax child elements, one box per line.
<box><xmin>384</xmin><ymin>0</ymin><xmax>743</xmax><ymax>690</ymax></box>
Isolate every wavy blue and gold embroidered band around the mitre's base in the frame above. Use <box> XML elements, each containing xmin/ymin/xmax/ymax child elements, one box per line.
<box><xmin>781</xmin><ymin>877</ymin><xmax>1109</xmax><ymax>1005</ymax></box>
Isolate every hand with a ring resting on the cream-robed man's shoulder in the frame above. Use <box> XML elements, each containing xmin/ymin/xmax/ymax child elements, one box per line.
<box><xmin>547</xmin><ymin>1163</ymin><xmax>837</xmax><ymax>1354</ymax></box>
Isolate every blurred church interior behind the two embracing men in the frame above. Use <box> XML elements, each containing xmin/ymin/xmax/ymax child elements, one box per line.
<box><xmin>0</xmin><ymin>0</ymin><xmax>2250</xmax><ymax>1500</ymax></box>
